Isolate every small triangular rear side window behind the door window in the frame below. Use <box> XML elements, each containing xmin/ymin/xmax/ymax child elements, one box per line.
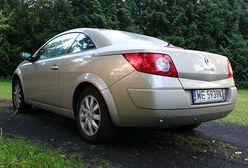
<box><xmin>69</xmin><ymin>34</ymin><xmax>96</xmax><ymax>53</ymax></box>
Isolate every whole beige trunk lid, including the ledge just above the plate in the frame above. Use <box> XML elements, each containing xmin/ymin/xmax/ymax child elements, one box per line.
<box><xmin>163</xmin><ymin>50</ymin><xmax>234</xmax><ymax>89</ymax></box>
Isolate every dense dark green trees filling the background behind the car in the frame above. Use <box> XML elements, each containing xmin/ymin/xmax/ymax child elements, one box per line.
<box><xmin>0</xmin><ymin>0</ymin><xmax>248</xmax><ymax>87</ymax></box>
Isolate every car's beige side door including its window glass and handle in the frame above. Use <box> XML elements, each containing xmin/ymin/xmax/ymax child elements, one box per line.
<box><xmin>23</xmin><ymin>33</ymin><xmax>78</xmax><ymax>106</ymax></box>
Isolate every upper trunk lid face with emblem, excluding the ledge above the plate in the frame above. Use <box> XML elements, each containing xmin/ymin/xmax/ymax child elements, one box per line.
<box><xmin>163</xmin><ymin>50</ymin><xmax>231</xmax><ymax>85</ymax></box>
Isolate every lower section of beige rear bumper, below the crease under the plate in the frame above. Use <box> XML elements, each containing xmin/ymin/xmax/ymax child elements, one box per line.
<box><xmin>113</xmin><ymin>104</ymin><xmax>234</xmax><ymax>127</ymax></box>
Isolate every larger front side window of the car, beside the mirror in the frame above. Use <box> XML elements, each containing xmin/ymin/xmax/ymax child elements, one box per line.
<box><xmin>38</xmin><ymin>33</ymin><xmax>78</xmax><ymax>59</ymax></box>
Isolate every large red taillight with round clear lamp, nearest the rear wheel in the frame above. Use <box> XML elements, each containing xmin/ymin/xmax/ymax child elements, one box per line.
<box><xmin>124</xmin><ymin>53</ymin><xmax>177</xmax><ymax>77</ymax></box>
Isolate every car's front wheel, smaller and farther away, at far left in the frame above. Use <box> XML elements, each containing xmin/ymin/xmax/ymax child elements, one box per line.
<box><xmin>12</xmin><ymin>79</ymin><xmax>32</xmax><ymax>113</ymax></box>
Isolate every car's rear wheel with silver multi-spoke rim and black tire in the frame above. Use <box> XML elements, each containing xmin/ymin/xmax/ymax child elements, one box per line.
<box><xmin>75</xmin><ymin>87</ymin><xmax>116</xmax><ymax>144</ymax></box>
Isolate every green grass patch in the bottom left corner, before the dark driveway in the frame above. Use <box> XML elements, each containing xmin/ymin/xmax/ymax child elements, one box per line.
<box><xmin>0</xmin><ymin>137</ymin><xmax>88</xmax><ymax>168</ymax></box>
